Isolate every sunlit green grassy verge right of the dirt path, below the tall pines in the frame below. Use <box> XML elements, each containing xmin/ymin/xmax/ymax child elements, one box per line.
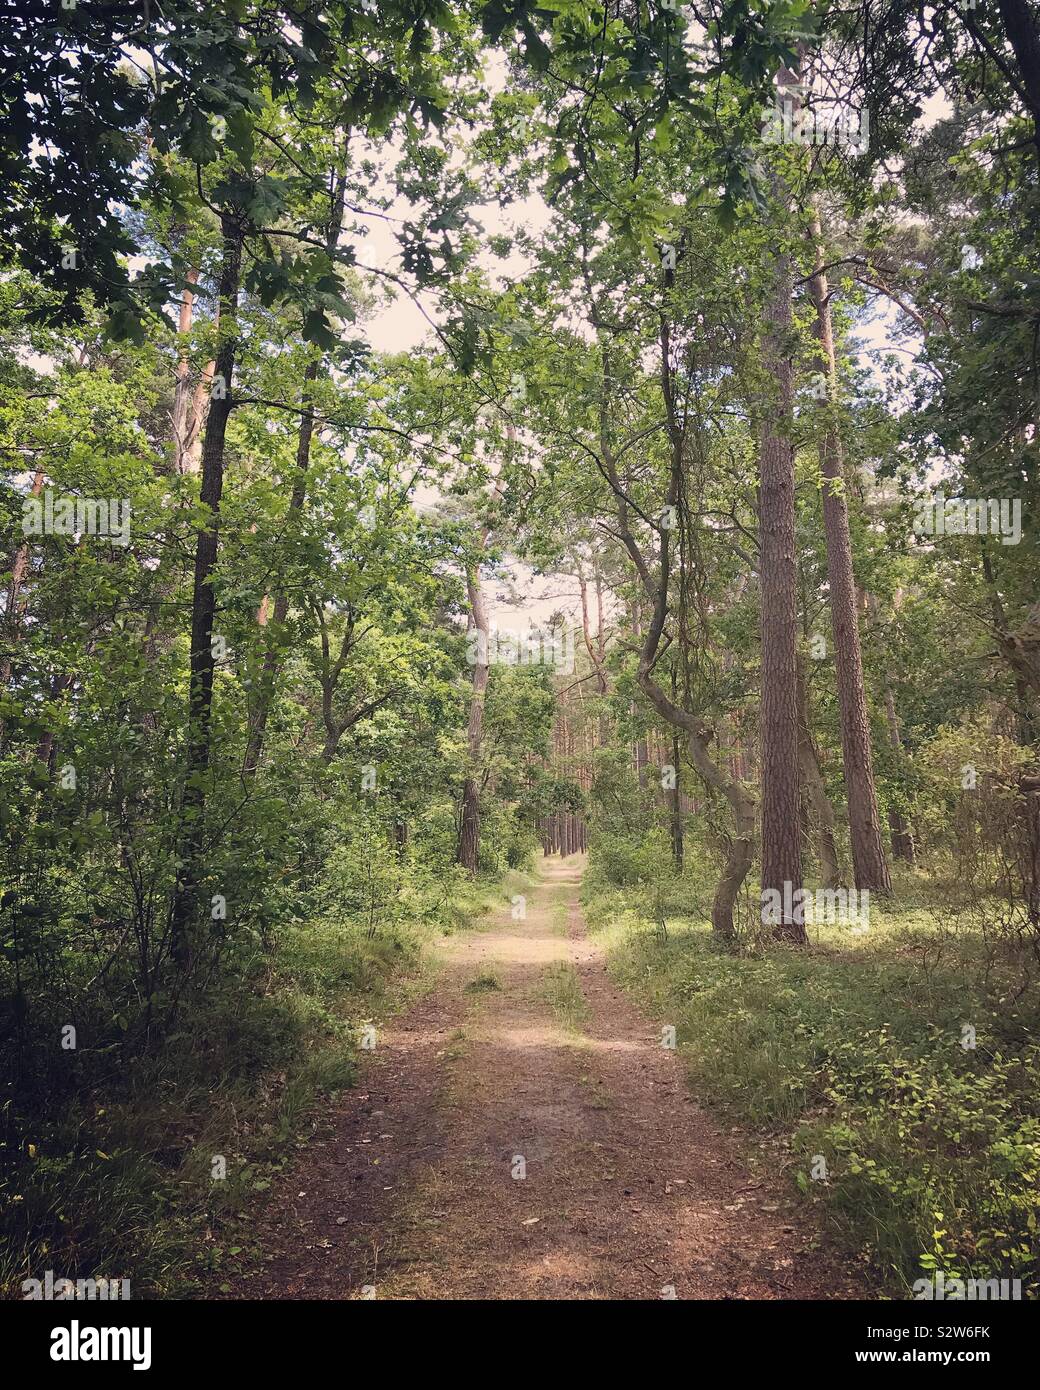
<box><xmin>587</xmin><ymin>880</ymin><xmax>1040</xmax><ymax>1298</ymax></box>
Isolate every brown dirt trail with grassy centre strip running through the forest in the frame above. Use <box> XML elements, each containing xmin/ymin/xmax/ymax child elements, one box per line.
<box><xmin>224</xmin><ymin>860</ymin><xmax>862</xmax><ymax>1298</ymax></box>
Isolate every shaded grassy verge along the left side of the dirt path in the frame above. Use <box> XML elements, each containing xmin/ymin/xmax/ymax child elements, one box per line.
<box><xmin>0</xmin><ymin>874</ymin><xmax>517</xmax><ymax>1298</ymax></box>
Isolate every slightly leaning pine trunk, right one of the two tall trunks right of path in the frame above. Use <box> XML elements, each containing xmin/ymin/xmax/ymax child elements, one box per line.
<box><xmin>809</xmin><ymin>209</ymin><xmax>891</xmax><ymax>892</ymax></box>
